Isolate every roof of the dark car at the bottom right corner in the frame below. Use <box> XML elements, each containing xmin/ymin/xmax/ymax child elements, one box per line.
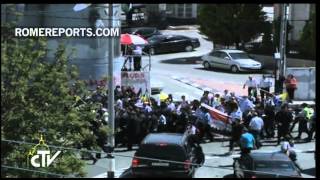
<box><xmin>250</xmin><ymin>152</ymin><xmax>291</xmax><ymax>161</ymax></box>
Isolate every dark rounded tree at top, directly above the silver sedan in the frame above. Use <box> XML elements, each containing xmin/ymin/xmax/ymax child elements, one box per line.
<box><xmin>198</xmin><ymin>4</ymin><xmax>266</xmax><ymax>48</ymax></box>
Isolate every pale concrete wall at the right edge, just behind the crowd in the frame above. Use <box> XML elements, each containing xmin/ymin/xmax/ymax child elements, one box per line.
<box><xmin>287</xmin><ymin>68</ymin><xmax>316</xmax><ymax>100</ymax></box>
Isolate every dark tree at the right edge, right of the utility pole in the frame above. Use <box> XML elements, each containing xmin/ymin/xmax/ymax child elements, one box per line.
<box><xmin>300</xmin><ymin>12</ymin><xmax>316</xmax><ymax>59</ymax></box>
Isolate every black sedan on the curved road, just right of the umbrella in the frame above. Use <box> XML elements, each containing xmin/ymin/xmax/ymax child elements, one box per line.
<box><xmin>144</xmin><ymin>35</ymin><xmax>200</xmax><ymax>55</ymax></box>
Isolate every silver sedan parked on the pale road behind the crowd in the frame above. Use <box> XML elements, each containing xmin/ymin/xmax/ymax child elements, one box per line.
<box><xmin>201</xmin><ymin>49</ymin><xmax>262</xmax><ymax>73</ymax></box>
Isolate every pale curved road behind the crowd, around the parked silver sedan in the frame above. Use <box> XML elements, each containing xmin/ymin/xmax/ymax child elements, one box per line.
<box><xmin>142</xmin><ymin>30</ymin><xmax>270</xmax><ymax>98</ymax></box>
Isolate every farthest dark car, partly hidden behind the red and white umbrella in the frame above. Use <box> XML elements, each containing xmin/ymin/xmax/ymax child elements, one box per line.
<box><xmin>121</xmin><ymin>27</ymin><xmax>161</xmax><ymax>39</ymax></box>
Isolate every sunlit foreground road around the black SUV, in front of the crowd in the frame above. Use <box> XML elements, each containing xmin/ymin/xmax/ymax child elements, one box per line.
<box><xmin>86</xmin><ymin>130</ymin><xmax>315</xmax><ymax>178</ymax></box>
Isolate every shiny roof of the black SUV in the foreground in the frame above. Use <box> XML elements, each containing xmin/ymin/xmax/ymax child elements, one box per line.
<box><xmin>141</xmin><ymin>133</ymin><xmax>185</xmax><ymax>145</ymax></box>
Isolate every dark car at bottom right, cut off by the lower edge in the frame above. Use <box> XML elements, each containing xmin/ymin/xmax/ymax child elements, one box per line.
<box><xmin>233</xmin><ymin>152</ymin><xmax>301</xmax><ymax>178</ymax></box>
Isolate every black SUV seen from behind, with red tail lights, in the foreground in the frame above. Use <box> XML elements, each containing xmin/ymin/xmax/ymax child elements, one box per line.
<box><xmin>131</xmin><ymin>133</ymin><xmax>204</xmax><ymax>177</ymax></box>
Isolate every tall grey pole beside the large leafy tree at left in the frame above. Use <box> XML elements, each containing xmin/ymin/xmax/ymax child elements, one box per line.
<box><xmin>107</xmin><ymin>3</ymin><xmax>115</xmax><ymax>178</ymax></box>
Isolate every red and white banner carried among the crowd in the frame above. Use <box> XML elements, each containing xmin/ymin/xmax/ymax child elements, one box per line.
<box><xmin>201</xmin><ymin>103</ymin><xmax>232</xmax><ymax>132</ymax></box>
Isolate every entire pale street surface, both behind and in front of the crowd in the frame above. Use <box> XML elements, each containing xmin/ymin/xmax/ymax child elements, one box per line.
<box><xmin>85</xmin><ymin>30</ymin><xmax>315</xmax><ymax>178</ymax></box>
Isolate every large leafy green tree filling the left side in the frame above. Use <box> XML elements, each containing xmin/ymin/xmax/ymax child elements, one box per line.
<box><xmin>1</xmin><ymin>8</ymin><xmax>108</xmax><ymax>177</ymax></box>
